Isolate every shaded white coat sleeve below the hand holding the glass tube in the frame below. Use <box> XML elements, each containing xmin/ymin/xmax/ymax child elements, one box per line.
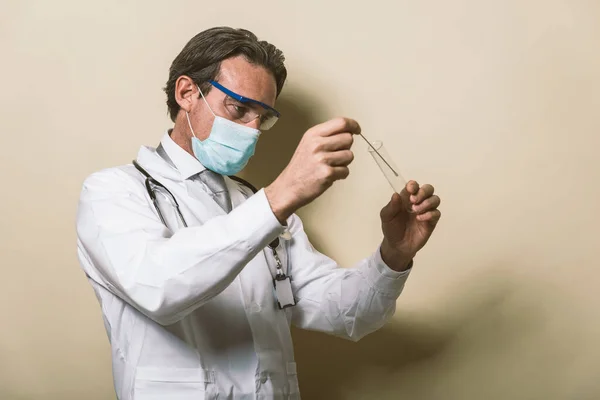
<box><xmin>289</xmin><ymin>216</ymin><xmax>410</xmax><ymax>341</ymax></box>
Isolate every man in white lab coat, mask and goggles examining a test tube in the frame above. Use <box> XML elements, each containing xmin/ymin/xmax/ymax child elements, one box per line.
<box><xmin>77</xmin><ymin>28</ymin><xmax>440</xmax><ymax>400</ymax></box>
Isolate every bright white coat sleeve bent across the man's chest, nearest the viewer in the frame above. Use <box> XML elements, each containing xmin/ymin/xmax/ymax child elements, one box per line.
<box><xmin>76</xmin><ymin>169</ymin><xmax>284</xmax><ymax>325</ymax></box>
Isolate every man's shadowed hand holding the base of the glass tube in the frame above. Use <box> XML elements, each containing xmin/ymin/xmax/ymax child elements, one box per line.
<box><xmin>380</xmin><ymin>181</ymin><xmax>441</xmax><ymax>271</ymax></box>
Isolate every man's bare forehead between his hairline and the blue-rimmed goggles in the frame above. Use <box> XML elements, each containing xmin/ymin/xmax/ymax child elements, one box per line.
<box><xmin>217</xmin><ymin>56</ymin><xmax>277</xmax><ymax>106</ymax></box>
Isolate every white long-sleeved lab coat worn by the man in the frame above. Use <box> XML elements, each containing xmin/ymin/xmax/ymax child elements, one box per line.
<box><xmin>77</xmin><ymin>134</ymin><xmax>408</xmax><ymax>400</ymax></box>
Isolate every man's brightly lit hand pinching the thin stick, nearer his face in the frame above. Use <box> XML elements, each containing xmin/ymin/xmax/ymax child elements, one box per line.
<box><xmin>265</xmin><ymin>118</ymin><xmax>360</xmax><ymax>224</ymax></box>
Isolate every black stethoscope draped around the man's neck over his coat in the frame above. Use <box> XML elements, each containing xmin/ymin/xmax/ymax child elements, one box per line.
<box><xmin>132</xmin><ymin>158</ymin><xmax>295</xmax><ymax>308</ymax></box>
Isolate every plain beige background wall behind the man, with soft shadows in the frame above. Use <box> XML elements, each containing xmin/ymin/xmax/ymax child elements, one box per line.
<box><xmin>0</xmin><ymin>0</ymin><xmax>600</xmax><ymax>400</ymax></box>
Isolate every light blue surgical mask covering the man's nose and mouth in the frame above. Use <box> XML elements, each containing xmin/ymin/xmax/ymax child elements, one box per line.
<box><xmin>185</xmin><ymin>87</ymin><xmax>260</xmax><ymax>175</ymax></box>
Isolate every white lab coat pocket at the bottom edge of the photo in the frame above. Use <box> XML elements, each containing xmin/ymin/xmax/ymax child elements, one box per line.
<box><xmin>133</xmin><ymin>367</ymin><xmax>214</xmax><ymax>400</ymax></box>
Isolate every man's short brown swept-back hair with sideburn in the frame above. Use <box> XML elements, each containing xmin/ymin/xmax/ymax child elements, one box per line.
<box><xmin>164</xmin><ymin>27</ymin><xmax>287</xmax><ymax>121</ymax></box>
